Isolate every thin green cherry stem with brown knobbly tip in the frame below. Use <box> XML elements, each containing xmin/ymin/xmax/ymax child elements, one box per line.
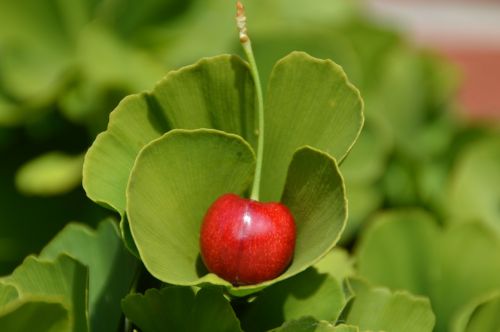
<box><xmin>236</xmin><ymin>1</ymin><xmax>264</xmax><ymax>201</ymax></box>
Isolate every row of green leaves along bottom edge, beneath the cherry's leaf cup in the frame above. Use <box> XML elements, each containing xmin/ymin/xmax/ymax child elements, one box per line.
<box><xmin>122</xmin><ymin>249</ymin><xmax>435</xmax><ymax>332</ymax></box>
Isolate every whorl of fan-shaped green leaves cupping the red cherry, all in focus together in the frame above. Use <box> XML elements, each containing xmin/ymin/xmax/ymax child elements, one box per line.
<box><xmin>83</xmin><ymin>53</ymin><xmax>362</xmax><ymax>295</ymax></box>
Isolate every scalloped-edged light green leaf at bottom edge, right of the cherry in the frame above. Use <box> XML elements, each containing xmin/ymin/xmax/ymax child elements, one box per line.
<box><xmin>347</xmin><ymin>281</ymin><xmax>435</xmax><ymax>332</ymax></box>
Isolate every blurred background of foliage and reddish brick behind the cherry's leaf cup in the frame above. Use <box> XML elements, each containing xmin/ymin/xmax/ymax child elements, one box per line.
<box><xmin>0</xmin><ymin>0</ymin><xmax>500</xmax><ymax>275</ymax></box>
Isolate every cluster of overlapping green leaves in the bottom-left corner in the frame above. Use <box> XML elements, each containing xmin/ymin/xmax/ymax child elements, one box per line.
<box><xmin>0</xmin><ymin>220</ymin><xmax>137</xmax><ymax>332</ymax></box>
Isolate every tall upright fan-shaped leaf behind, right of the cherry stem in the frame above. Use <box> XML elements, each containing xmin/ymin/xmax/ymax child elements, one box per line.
<box><xmin>261</xmin><ymin>52</ymin><xmax>363</xmax><ymax>201</ymax></box>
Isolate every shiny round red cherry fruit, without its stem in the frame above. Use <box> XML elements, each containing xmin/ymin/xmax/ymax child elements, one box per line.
<box><xmin>200</xmin><ymin>194</ymin><xmax>296</xmax><ymax>286</ymax></box>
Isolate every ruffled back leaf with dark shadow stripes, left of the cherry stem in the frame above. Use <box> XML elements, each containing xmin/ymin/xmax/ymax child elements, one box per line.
<box><xmin>83</xmin><ymin>55</ymin><xmax>255</xmax><ymax>215</ymax></box>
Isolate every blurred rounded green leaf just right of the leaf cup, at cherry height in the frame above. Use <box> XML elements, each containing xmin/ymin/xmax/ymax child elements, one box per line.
<box><xmin>357</xmin><ymin>211</ymin><xmax>439</xmax><ymax>294</ymax></box>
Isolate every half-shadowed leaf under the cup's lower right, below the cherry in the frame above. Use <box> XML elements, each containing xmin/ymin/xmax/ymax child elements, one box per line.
<box><xmin>240</xmin><ymin>268</ymin><xmax>345</xmax><ymax>331</ymax></box>
